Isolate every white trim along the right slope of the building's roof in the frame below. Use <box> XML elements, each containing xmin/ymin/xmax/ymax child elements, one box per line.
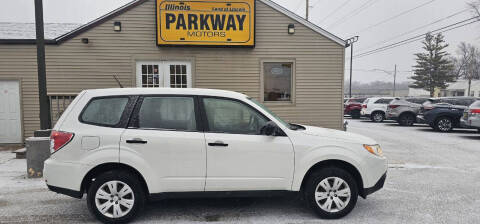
<box><xmin>258</xmin><ymin>0</ymin><xmax>346</xmax><ymax>46</ymax></box>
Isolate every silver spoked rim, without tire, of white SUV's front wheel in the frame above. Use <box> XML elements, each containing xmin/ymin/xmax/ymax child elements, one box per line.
<box><xmin>315</xmin><ymin>177</ymin><xmax>351</xmax><ymax>213</ymax></box>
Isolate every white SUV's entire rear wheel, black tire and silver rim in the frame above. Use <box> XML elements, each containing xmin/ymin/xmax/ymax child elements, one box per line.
<box><xmin>87</xmin><ymin>171</ymin><xmax>145</xmax><ymax>223</ymax></box>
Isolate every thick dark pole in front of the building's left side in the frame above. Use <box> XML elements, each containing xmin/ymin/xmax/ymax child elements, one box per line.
<box><xmin>35</xmin><ymin>0</ymin><xmax>52</xmax><ymax>130</ymax></box>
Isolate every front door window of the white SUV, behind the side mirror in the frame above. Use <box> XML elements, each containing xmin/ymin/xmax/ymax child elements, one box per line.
<box><xmin>203</xmin><ymin>98</ymin><xmax>269</xmax><ymax>135</ymax></box>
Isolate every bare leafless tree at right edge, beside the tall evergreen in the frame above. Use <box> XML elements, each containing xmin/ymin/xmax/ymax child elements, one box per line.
<box><xmin>453</xmin><ymin>42</ymin><xmax>480</xmax><ymax>95</ymax></box>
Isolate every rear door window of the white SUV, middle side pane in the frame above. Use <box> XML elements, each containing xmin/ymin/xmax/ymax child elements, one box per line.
<box><xmin>136</xmin><ymin>97</ymin><xmax>197</xmax><ymax>131</ymax></box>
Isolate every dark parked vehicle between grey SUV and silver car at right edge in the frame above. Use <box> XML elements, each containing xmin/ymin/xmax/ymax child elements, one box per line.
<box><xmin>417</xmin><ymin>97</ymin><xmax>478</xmax><ymax>132</ymax></box>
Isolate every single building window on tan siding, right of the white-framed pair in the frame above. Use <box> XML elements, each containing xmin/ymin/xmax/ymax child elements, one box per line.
<box><xmin>263</xmin><ymin>62</ymin><xmax>294</xmax><ymax>102</ymax></box>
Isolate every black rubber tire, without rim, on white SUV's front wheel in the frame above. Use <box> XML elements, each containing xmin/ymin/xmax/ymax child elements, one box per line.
<box><xmin>303</xmin><ymin>167</ymin><xmax>358</xmax><ymax>219</ymax></box>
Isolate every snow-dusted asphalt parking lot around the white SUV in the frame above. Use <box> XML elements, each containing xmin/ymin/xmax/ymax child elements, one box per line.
<box><xmin>0</xmin><ymin>119</ymin><xmax>480</xmax><ymax>223</ymax></box>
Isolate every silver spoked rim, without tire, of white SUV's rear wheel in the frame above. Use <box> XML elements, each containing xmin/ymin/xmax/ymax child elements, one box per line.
<box><xmin>95</xmin><ymin>180</ymin><xmax>135</xmax><ymax>218</ymax></box>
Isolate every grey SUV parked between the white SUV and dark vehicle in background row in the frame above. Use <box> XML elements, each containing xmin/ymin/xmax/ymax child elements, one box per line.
<box><xmin>386</xmin><ymin>98</ymin><xmax>429</xmax><ymax>126</ymax></box>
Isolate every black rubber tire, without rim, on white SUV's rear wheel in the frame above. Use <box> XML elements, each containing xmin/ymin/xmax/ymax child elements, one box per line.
<box><xmin>87</xmin><ymin>171</ymin><xmax>146</xmax><ymax>223</ymax></box>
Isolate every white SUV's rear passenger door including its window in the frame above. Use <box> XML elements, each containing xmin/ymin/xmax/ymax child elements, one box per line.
<box><xmin>120</xmin><ymin>96</ymin><xmax>206</xmax><ymax>193</ymax></box>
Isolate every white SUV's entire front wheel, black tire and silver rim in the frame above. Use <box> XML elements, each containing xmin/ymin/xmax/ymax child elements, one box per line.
<box><xmin>304</xmin><ymin>167</ymin><xmax>358</xmax><ymax>219</ymax></box>
